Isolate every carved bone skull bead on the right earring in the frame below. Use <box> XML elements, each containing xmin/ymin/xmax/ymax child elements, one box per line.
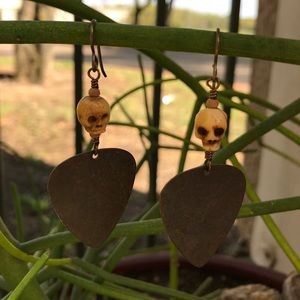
<box><xmin>194</xmin><ymin>108</ymin><xmax>227</xmax><ymax>152</ymax></box>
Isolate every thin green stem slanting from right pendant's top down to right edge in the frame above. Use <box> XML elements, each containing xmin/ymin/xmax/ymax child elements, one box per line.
<box><xmin>230</xmin><ymin>150</ymin><xmax>300</xmax><ymax>272</ymax></box>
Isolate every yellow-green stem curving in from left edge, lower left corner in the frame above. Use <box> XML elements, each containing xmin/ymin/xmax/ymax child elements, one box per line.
<box><xmin>0</xmin><ymin>231</ymin><xmax>71</xmax><ymax>266</ymax></box>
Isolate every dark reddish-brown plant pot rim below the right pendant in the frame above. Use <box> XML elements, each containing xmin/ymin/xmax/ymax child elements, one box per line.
<box><xmin>114</xmin><ymin>252</ymin><xmax>287</xmax><ymax>292</ymax></box>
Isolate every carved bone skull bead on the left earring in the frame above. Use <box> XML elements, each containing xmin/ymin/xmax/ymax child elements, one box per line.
<box><xmin>77</xmin><ymin>96</ymin><xmax>110</xmax><ymax>138</ymax></box>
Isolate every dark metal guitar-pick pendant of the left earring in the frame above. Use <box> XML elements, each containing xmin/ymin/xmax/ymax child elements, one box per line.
<box><xmin>48</xmin><ymin>149</ymin><xmax>136</xmax><ymax>248</ymax></box>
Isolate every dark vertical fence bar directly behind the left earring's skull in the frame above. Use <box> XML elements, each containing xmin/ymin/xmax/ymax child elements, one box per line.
<box><xmin>73</xmin><ymin>16</ymin><xmax>83</xmax><ymax>154</ymax></box>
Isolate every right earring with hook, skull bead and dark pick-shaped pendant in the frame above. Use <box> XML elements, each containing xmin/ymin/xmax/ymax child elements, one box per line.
<box><xmin>160</xmin><ymin>29</ymin><xmax>245</xmax><ymax>267</ymax></box>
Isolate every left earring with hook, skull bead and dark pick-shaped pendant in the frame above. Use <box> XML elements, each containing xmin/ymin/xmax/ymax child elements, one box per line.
<box><xmin>48</xmin><ymin>20</ymin><xmax>136</xmax><ymax>248</ymax></box>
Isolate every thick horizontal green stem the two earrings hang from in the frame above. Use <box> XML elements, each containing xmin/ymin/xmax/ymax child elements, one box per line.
<box><xmin>0</xmin><ymin>19</ymin><xmax>300</xmax><ymax>64</ymax></box>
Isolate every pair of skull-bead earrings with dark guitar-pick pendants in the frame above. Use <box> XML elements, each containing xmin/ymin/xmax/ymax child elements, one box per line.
<box><xmin>48</xmin><ymin>20</ymin><xmax>245</xmax><ymax>267</ymax></box>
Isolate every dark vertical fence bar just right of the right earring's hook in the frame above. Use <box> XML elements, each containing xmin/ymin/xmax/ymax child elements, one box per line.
<box><xmin>225</xmin><ymin>0</ymin><xmax>241</xmax><ymax>134</ymax></box>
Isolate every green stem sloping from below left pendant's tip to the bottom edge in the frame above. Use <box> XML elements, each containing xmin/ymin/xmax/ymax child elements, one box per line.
<box><xmin>73</xmin><ymin>259</ymin><xmax>199</xmax><ymax>300</ymax></box>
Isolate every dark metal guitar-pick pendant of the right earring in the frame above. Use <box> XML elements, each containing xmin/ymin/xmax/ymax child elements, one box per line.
<box><xmin>160</xmin><ymin>165</ymin><xmax>246</xmax><ymax>267</ymax></box>
